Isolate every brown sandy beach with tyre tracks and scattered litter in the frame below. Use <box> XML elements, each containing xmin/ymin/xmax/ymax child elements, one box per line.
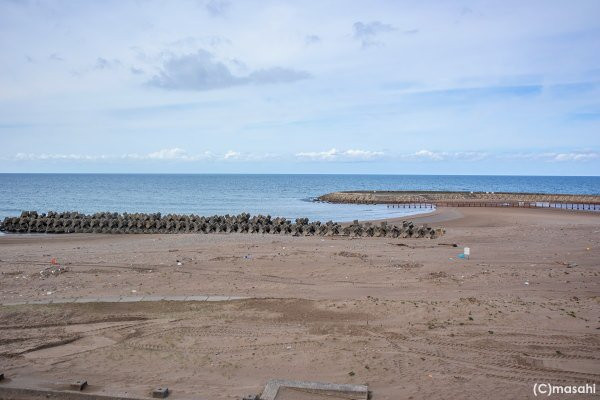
<box><xmin>0</xmin><ymin>208</ymin><xmax>600</xmax><ymax>399</ymax></box>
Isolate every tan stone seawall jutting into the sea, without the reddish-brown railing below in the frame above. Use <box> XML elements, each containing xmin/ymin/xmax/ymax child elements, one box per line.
<box><xmin>317</xmin><ymin>191</ymin><xmax>600</xmax><ymax>204</ymax></box>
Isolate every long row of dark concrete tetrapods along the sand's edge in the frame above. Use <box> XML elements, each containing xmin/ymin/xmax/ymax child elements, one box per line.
<box><xmin>0</xmin><ymin>211</ymin><xmax>445</xmax><ymax>239</ymax></box>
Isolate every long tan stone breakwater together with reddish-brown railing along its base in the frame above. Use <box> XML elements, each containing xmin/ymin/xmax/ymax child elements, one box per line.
<box><xmin>317</xmin><ymin>191</ymin><xmax>600</xmax><ymax>211</ymax></box>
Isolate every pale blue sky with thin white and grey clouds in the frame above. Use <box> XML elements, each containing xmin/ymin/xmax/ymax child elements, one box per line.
<box><xmin>0</xmin><ymin>0</ymin><xmax>600</xmax><ymax>175</ymax></box>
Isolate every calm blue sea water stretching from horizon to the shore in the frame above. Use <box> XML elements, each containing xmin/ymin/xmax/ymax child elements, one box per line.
<box><xmin>0</xmin><ymin>174</ymin><xmax>600</xmax><ymax>222</ymax></box>
